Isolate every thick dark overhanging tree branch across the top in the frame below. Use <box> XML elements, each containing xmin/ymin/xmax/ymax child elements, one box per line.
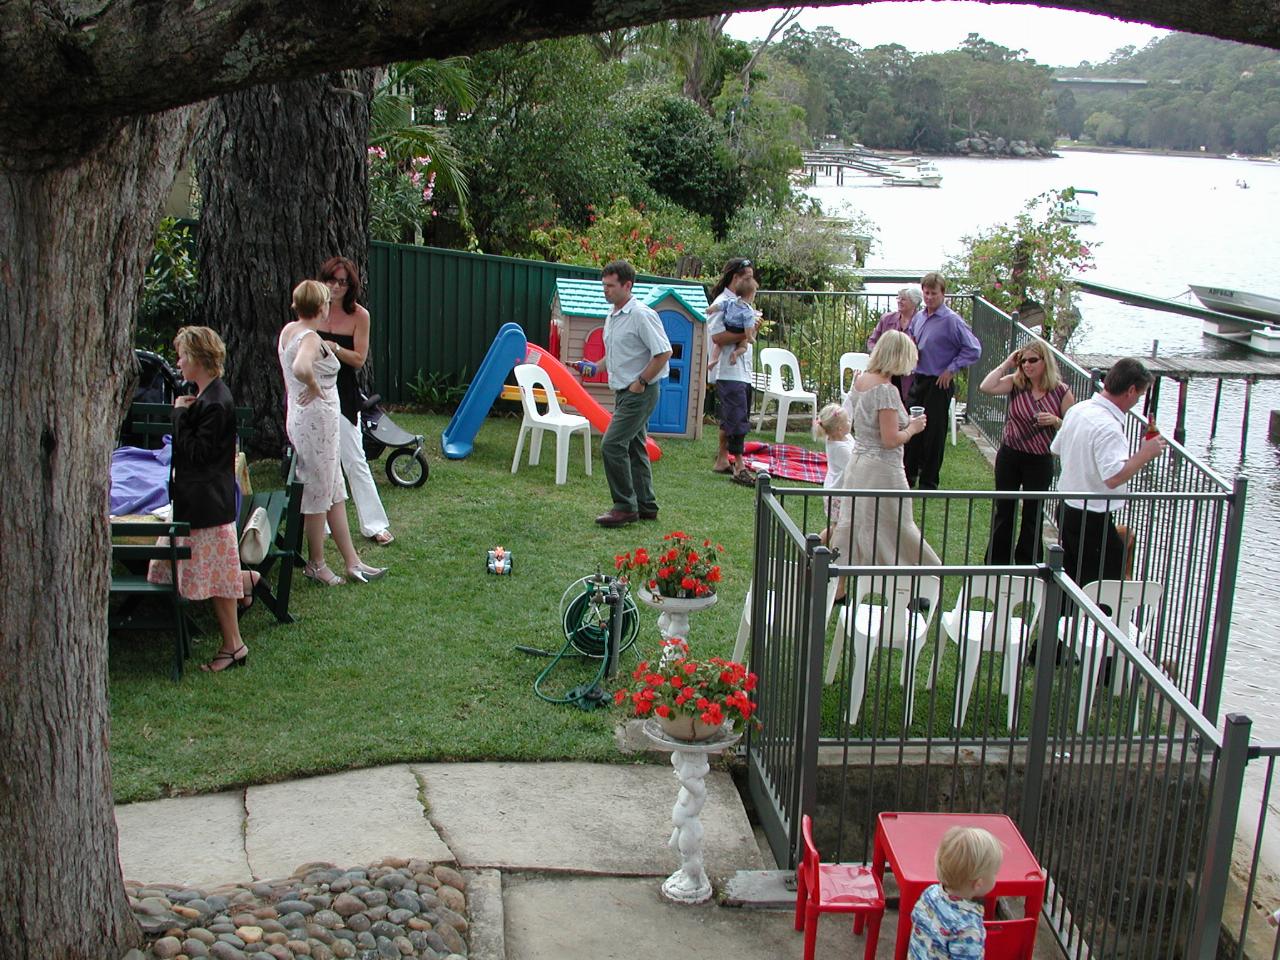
<box><xmin>0</xmin><ymin>0</ymin><xmax>1280</xmax><ymax>165</ymax></box>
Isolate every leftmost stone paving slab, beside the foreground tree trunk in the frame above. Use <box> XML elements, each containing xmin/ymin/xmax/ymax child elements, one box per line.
<box><xmin>115</xmin><ymin>790</ymin><xmax>253</xmax><ymax>887</ymax></box>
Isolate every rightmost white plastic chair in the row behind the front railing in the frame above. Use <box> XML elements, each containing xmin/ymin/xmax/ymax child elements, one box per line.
<box><xmin>1059</xmin><ymin>580</ymin><xmax>1165</xmax><ymax>733</ymax></box>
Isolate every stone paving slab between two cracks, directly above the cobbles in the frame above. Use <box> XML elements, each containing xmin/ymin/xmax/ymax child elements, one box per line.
<box><xmin>244</xmin><ymin>765</ymin><xmax>454</xmax><ymax>879</ymax></box>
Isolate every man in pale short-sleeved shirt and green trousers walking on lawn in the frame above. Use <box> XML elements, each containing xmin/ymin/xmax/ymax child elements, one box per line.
<box><xmin>575</xmin><ymin>260</ymin><xmax>671</xmax><ymax>527</ymax></box>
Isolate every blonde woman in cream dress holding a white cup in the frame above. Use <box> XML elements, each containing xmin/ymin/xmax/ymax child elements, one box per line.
<box><xmin>831</xmin><ymin>330</ymin><xmax>940</xmax><ymax>566</ymax></box>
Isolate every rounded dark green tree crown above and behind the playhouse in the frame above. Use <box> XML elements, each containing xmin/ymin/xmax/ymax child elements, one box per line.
<box><xmin>622</xmin><ymin>93</ymin><xmax>742</xmax><ymax>233</ymax></box>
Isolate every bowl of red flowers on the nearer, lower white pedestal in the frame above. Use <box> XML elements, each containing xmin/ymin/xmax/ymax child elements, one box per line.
<box><xmin>613</xmin><ymin>637</ymin><xmax>756</xmax><ymax>741</ymax></box>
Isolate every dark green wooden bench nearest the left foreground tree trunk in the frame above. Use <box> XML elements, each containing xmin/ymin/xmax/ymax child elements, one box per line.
<box><xmin>108</xmin><ymin>520</ymin><xmax>193</xmax><ymax>680</ymax></box>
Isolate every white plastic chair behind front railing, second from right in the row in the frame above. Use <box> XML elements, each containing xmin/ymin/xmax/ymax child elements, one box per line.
<box><xmin>928</xmin><ymin>576</ymin><xmax>1044</xmax><ymax>730</ymax></box>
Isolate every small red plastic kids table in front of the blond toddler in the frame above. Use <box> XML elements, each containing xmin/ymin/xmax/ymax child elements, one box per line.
<box><xmin>872</xmin><ymin>813</ymin><xmax>1044</xmax><ymax>960</ymax></box>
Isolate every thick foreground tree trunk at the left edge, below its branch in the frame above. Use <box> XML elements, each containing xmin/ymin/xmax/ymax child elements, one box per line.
<box><xmin>0</xmin><ymin>108</ymin><xmax>202</xmax><ymax>960</ymax></box>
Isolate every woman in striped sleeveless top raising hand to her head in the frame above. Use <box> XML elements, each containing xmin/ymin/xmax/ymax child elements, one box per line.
<box><xmin>978</xmin><ymin>340</ymin><xmax>1075</xmax><ymax>563</ymax></box>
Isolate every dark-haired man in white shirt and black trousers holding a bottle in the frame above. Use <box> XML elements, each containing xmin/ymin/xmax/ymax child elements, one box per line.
<box><xmin>1050</xmin><ymin>357</ymin><xmax>1169</xmax><ymax>584</ymax></box>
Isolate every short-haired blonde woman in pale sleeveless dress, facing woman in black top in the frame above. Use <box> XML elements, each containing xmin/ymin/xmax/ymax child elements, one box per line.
<box><xmin>276</xmin><ymin>280</ymin><xmax>387</xmax><ymax>586</ymax></box>
